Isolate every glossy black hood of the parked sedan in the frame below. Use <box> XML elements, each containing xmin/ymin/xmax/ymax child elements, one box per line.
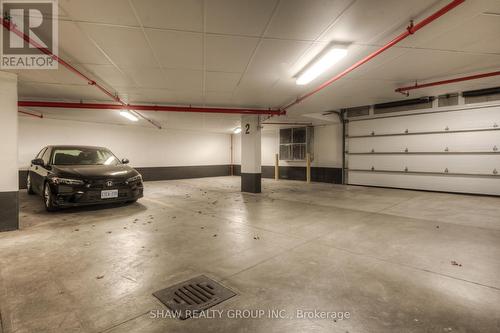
<box><xmin>52</xmin><ymin>165</ymin><xmax>139</xmax><ymax>179</ymax></box>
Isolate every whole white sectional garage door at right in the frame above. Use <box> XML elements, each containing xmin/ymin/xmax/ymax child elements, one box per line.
<box><xmin>346</xmin><ymin>106</ymin><xmax>500</xmax><ymax>195</ymax></box>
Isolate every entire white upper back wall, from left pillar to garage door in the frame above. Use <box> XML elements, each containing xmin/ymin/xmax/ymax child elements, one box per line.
<box><xmin>18</xmin><ymin>116</ymin><xmax>342</xmax><ymax>169</ymax></box>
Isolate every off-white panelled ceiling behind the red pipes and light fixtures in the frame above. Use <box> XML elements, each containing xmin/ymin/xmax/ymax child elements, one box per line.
<box><xmin>10</xmin><ymin>0</ymin><xmax>500</xmax><ymax>130</ymax></box>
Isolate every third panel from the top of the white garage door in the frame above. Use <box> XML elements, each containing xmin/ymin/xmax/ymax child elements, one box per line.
<box><xmin>349</xmin><ymin>154</ymin><xmax>500</xmax><ymax>175</ymax></box>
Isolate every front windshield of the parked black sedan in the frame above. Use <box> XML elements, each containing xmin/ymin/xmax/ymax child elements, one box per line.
<box><xmin>52</xmin><ymin>147</ymin><xmax>121</xmax><ymax>165</ymax></box>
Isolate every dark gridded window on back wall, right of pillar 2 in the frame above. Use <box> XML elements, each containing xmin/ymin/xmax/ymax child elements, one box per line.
<box><xmin>279</xmin><ymin>126</ymin><xmax>314</xmax><ymax>161</ymax></box>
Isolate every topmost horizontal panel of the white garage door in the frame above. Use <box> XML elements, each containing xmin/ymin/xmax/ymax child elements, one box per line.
<box><xmin>349</xmin><ymin>107</ymin><xmax>500</xmax><ymax>136</ymax></box>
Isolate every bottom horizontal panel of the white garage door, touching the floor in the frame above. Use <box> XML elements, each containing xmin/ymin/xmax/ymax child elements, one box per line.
<box><xmin>349</xmin><ymin>172</ymin><xmax>500</xmax><ymax>195</ymax></box>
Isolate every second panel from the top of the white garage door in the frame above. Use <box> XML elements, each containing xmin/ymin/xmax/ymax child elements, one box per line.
<box><xmin>348</xmin><ymin>131</ymin><xmax>500</xmax><ymax>153</ymax></box>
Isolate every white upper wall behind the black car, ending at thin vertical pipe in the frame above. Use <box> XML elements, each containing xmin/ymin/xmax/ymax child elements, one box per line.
<box><xmin>16</xmin><ymin>117</ymin><xmax>231</xmax><ymax>169</ymax></box>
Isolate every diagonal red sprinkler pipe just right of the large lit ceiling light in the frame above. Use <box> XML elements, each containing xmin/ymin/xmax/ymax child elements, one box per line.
<box><xmin>281</xmin><ymin>0</ymin><xmax>465</xmax><ymax>111</ymax></box>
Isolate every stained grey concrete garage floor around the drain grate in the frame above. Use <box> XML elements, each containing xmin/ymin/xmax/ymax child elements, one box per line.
<box><xmin>0</xmin><ymin>177</ymin><xmax>500</xmax><ymax>333</ymax></box>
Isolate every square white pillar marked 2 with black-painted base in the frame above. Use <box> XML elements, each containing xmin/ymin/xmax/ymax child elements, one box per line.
<box><xmin>241</xmin><ymin>115</ymin><xmax>262</xmax><ymax>193</ymax></box>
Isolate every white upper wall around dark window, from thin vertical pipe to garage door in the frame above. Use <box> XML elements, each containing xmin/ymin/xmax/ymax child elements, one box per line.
<box><xmin>233</xmin><ymin>124</ymin><xmax>342</xmax><ymax>168</ymax></box>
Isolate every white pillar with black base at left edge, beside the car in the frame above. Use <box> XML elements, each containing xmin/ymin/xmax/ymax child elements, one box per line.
<box><xmin>0</xmin><ymin>72</ymin><xmax>19</xmax><ymax>231</ymax></box>
